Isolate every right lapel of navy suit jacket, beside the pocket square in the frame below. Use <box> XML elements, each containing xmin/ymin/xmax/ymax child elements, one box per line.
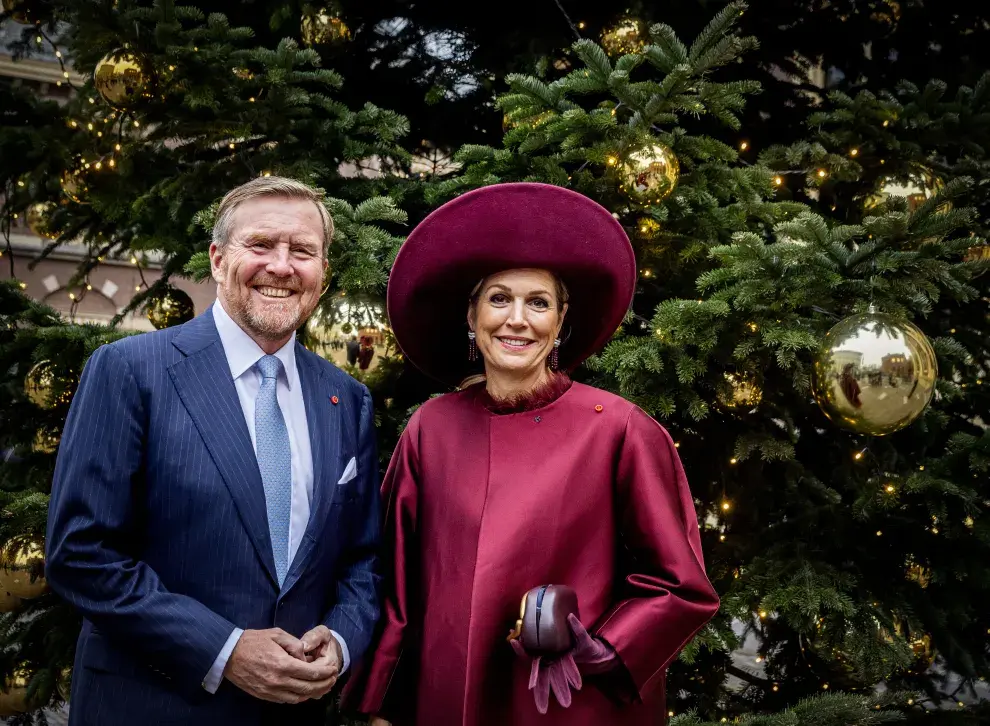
<box><xmin>282</xmin><ymin>344</ymin><xmax>342</xmax><ymax>593</ymax></box>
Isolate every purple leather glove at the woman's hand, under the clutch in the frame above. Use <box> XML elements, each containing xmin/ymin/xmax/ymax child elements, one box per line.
<box><xmin>509</xmin><ymin>615</ymin><xmax>618</xmax><ymax>714</ymax></box>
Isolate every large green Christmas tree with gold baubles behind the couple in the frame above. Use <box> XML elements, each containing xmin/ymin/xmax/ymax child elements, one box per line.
<box><xmin>0</xmin><ymin>0</ymin><xmax>990</xmax><ymax>726</ymax></box>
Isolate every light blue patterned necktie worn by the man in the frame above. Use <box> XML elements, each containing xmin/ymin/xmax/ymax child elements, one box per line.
<box><xmin>254</xmin><ymin>355</ymin><xmax>292</xmax><ymax>587</ymax></box>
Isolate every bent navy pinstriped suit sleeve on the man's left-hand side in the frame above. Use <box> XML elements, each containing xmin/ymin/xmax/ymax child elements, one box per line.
<box><xmin>45</xmin><ymin>345</ymin><xmax>234</xmax><ymax>692</ymax></box>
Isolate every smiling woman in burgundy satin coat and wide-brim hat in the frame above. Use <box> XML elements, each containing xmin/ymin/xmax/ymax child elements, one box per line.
<box><xmin>348</xmin><ymin>184</ymin><xmax>718</xmax><ymax>726</ymax></box>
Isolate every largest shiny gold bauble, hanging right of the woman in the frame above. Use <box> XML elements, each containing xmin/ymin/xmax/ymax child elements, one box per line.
<box><xmin>811</xmin><ymin>313</ymin><xmax>938</xmax><ymax>436</ymax></box>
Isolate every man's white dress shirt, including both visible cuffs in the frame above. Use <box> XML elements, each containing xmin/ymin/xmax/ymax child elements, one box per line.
<box><xmin>203</xmin><ymin>299</ymin><xmax>350</xmax><ymax>693</ymax></box>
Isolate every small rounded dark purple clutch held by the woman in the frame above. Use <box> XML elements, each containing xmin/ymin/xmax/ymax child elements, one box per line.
<box><xmin>508</xmin><ymin>585</ymin><xmax>580</xmax><ymax>655</ymax></box>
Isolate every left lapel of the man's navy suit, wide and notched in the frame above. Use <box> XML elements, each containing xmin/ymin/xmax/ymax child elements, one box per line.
<box><xmin>169</xmin><ymin>310</ymin><xmax>278</xmax><ymax>587</ymax></box>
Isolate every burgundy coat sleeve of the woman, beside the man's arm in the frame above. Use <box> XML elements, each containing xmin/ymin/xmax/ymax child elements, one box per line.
<box><xmin>344</xmin><ymin>412</ymin><xmax>420</xmax><ymax>718</ymax></box>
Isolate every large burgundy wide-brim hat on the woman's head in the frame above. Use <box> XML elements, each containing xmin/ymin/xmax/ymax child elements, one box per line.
<box><xmin>388</xmin><ymin>183</ymin><xmax>636</xmax><ymax>385</ymax></box>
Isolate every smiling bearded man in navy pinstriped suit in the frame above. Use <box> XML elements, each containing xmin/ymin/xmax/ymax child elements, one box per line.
<box><xmin>47</xmin><ymin>177</ymin><xmax>379</xmax><ymax>726</ymax></box>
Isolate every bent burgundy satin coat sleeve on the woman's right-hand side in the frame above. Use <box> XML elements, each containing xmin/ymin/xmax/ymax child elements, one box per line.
<box><xmin>594</xmin><ymin>408</ymin><xmax>719</xmax><ymax>698</ymax></box>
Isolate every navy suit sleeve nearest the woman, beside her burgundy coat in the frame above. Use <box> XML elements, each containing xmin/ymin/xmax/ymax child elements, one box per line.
<box><xmin>325</xmin><ymin>386</ymin><xmax>381</xmax><ymax>661</ymax></box>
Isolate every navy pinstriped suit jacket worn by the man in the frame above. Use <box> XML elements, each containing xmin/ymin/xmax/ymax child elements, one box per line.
<box><xmin>46</xmin><ymin>310</ymin><xmax>379</xmax><ymax>726</ymax></box>
